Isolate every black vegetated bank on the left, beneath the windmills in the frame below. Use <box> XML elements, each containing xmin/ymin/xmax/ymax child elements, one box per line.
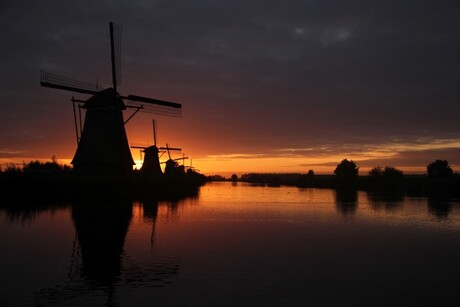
<box><xmin>0</xmin><ymin>160</ymin><xmax>206</xmax><ymax>204</ymax></box>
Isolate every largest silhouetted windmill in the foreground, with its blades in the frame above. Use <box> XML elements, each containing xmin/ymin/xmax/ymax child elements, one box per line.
<box><xmin>40</xmin><ymin>22</ymin><xmax>182</xmax><ymax>175</ymax></box>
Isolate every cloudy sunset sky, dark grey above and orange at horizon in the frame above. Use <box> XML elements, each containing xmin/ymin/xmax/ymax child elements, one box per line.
<box><xmin>0</xmin><ymin>0</ymin><xmax>460</xmax><ymax>175</ymax></box>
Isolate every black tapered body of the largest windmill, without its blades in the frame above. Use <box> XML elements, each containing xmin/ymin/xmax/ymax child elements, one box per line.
<box><xmin>72</xmin><ymin>88</ymin><xmax>134</xmax><ymax>175</ymax></box>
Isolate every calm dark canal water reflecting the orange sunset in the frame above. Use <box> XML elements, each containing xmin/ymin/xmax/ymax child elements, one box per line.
<box><xmin>0</xmin><ymin>183</ymin><xmax>460</xmax><ymax>306</ymax></box>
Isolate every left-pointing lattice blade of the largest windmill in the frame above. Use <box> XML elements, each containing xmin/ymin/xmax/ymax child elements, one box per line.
<box><xmin>40</xmin><ymin>70</ymin><xmax>99</xmax><ymax>95</ymax></box>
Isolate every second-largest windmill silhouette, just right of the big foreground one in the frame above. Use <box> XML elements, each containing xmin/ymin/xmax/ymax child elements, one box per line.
<box><xmin>131</xmin><ymin>119</ymin><xmax>181</xmax><ymax>175</ymax></box>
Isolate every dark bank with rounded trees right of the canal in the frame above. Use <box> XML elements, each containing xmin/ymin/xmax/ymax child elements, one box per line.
<box><xmin>232</xmin><ymin>159</ymin><xmax>460</xmax><ymax>197</ymax></box>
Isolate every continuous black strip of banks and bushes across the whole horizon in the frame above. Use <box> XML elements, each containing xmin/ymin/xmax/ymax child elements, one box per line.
<box><xmin>0</xmin><ymin>159</ymin><xmax>460</xmax><ymax>203</ymax></box>
